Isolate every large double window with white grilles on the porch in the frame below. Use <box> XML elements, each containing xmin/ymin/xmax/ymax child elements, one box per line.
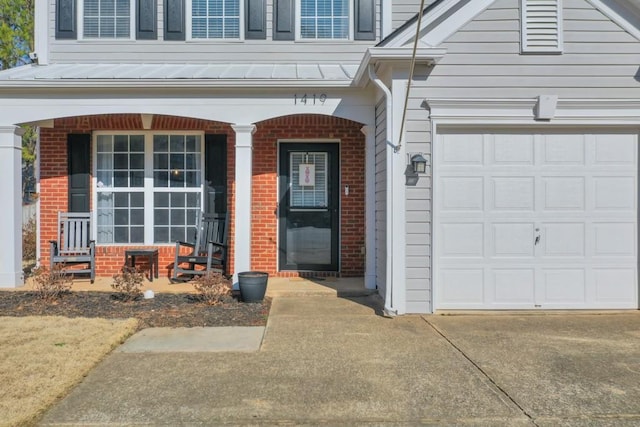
<box><xmin>94</xmin><ymin>132</ymin><xmax>203</xmax><ymax>245</ymax></box>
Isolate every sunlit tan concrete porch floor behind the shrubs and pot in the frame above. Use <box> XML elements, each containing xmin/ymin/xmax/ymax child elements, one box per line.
<box><xmin>17</xmin><ymin>277</ymin><xmax>376</xmax><ymax>297</ymax></box>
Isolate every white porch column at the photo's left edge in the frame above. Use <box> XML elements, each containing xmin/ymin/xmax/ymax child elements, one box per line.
<box><xmin>0</xmin><ymin>126</ymin><xmax>24</xmax><ymax>288</ymax></box>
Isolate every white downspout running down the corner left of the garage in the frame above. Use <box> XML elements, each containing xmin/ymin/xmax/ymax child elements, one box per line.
<box><xmin>368</xmin><ymin>64</ymin><xmax>399</xmax><ymax>317</ymax></box>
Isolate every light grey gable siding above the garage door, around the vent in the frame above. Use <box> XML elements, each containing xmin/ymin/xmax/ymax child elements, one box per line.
<box><xmin>419</xmin><ymin>0</ymin><xmax>640</xmax><ymax>99</ymax></box>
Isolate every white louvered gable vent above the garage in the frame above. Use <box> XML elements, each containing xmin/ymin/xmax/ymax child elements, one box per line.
<box><xmin>521</xmin><ymin>0</ymin><xmax>562</xmax><ymax>53</ymax></box>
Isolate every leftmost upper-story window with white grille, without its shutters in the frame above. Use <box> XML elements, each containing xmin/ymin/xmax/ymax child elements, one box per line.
<box><xmin>81</xmin><ymin>0</ymin><xmax>133</xmax><ymax>39</ymax></box>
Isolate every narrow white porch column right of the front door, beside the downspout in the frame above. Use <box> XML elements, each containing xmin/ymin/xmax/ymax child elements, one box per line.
<box><xmin>360</xmin><ymin>126</ymin><xmax>376</xmax><ymax>289</ymax></box>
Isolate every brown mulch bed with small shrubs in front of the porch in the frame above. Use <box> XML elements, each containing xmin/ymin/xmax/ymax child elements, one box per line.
<box><xmin>0</xmin><ymin>291</ymin><xmax>271</xmax><ymax>329</ymax></box>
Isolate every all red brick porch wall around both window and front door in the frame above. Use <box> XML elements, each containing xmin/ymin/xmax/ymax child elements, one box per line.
<box><xmin>40</xmin><ymin>114</ymin><xmax>364</xmax><ymax>276</ymax></box>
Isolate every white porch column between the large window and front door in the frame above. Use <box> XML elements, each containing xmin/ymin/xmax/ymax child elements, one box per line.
<box><xmin>231</xmin><ymin>124</ymin><xmax>256</xmax><ymax>287</ymax></box>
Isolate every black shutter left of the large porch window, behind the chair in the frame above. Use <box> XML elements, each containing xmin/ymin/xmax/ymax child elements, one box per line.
<box><xmin>67</xmin><ymin>133</ymin><xmax>91</xmax><ymax>212</ymax></box>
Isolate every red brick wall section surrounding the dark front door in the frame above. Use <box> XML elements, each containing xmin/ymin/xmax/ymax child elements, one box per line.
<box><xmin>251</xmin><ymin>115</ymin><xmax>365</xmax><ymax>277</ymax></box>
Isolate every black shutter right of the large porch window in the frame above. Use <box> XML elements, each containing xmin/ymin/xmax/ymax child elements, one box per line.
<box><xmin>204</xmin><ymin>134</ymin><xmax>227</xmax><ymax>213</ymax></box>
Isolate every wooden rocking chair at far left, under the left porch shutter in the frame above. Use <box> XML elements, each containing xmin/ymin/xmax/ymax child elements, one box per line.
<box><xmin>49</xmin><ymin>212</ymin><xmax>96</xmax><ymax>283</ymax></box>
